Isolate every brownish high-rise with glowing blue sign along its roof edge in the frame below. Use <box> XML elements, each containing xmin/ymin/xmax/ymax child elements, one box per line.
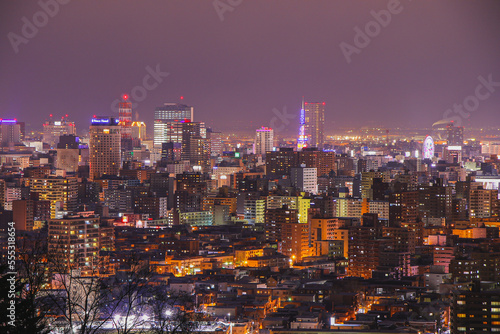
<box><xmin>89</xmin><ymin>117</ymin><xmax>121</xmax><ymax>179</ymax></box>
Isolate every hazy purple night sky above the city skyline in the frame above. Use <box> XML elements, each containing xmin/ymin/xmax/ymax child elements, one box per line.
<box><xmin>0</xmin><ymin>0</ymin><xmax>500</xmax><ymax>133</ymax></box>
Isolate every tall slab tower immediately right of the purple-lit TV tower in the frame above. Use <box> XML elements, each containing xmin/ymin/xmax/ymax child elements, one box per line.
<box><xmin>304</xmin><ymin>102</ymin><xmax>325</xmax><ymax>150</ymax></box>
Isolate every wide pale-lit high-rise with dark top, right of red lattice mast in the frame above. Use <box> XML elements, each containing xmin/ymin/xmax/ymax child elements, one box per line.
<box><xmin>154</xmin><ymin>103</ymin><xmax>194</xmax><ymax>147</ymax></box>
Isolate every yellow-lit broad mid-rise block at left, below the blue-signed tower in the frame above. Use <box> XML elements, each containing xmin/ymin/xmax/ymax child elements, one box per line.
<box><xmin>30</xmin><ymin>177</ymin><xmax>78</xmax><ymax>218</ymax></box>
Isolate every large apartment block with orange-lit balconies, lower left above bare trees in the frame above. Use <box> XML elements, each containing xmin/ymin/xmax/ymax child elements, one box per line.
<box><xmin>49</xmin><ymin>216</ymin><xmax>99</xmax><ymax>268</ymax></box>
